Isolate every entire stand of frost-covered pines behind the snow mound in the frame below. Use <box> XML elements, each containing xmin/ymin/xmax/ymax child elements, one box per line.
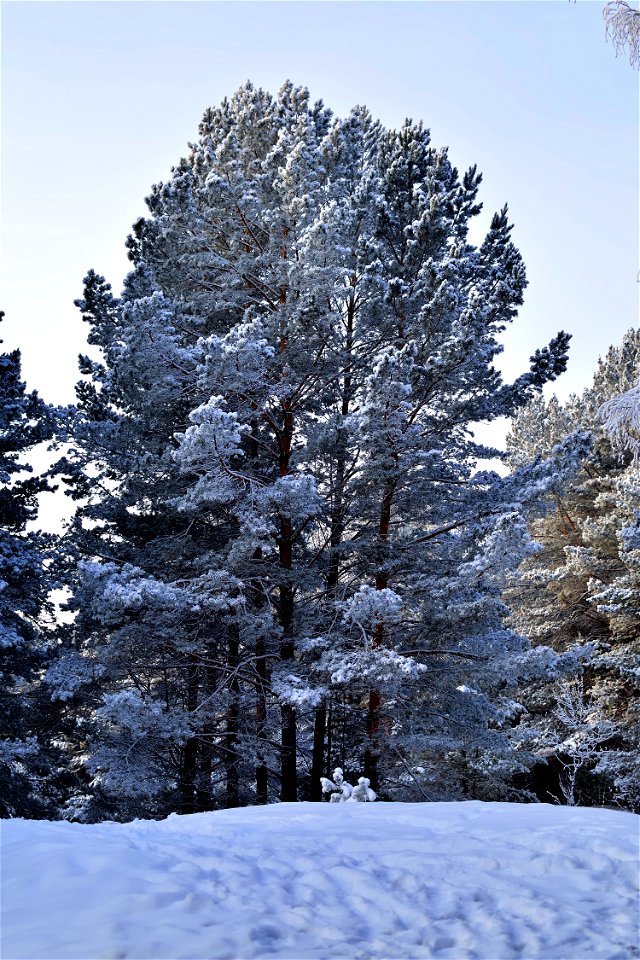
<box><xmin>0</xmin><ymin>82</ymin><xmax>640</xmax><ymax>823</ymax></box>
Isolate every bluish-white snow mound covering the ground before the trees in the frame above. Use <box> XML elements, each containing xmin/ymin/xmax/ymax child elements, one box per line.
<box><xmin>1</xmin><ymin>801</ymin><xmax>640</xmax><ymax>960</ymax></box>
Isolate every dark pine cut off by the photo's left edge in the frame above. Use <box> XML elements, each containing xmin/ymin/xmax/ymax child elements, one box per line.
<box><xmin>0</xmin><ymin>313</ymin><xmax>59</xmax><ymax>817</ymax></box>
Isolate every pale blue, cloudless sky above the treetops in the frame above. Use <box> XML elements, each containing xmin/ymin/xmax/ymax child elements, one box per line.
<box><xmin>0</xmin><ymin>0</ymin><xmax>639</xmax><ymax>414</ymax></box>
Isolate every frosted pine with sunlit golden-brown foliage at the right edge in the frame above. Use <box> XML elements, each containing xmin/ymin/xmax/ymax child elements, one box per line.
<box><xmin>508</xmin><ymin>330</ymin><xmax>640</xmax><ymax>809</ymax></box>
